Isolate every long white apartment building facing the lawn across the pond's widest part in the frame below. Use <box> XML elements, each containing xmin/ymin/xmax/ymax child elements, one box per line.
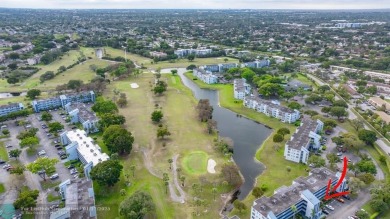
<box><xmin>243</xmin><ymin>96</ymin><xmax>300</xmax><ymax>123</ymax></box>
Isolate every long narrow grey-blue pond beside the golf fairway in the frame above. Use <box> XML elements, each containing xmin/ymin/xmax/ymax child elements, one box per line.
<box><xmin>178</xmin><ymin>69</ymin><xmax>272</xmax><ymax>199</ymax></box>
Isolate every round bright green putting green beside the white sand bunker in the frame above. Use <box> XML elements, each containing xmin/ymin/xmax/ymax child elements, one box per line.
<box><xmin>182</xmin><ymin>151</ymin><xmax>209</xmax><ymax>174</ymax></box>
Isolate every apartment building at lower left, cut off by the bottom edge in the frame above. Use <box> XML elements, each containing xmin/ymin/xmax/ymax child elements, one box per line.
<box><xmin>50</xmin><ymin>179</ymin><xmax>97</xmax><ymax>219</ymax></box>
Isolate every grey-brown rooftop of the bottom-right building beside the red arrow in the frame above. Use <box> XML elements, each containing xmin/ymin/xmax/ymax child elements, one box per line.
<box><xmin>253</xmin><ymin>167</ymin><xmax>339</xmax><ymax>215</ymax></box>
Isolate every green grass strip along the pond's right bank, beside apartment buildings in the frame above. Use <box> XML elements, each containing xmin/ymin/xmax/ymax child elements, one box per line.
<box><xmin>185</xmin><ymin>73</ymin><xmax>308</xmax><ymax>218</ymax></box>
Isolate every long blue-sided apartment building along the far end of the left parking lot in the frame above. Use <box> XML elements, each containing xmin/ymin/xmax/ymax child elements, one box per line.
<box><xmin>31</xmin><ymin>91</ymin><xmax>96</xmax><ymax>113</ymax></box>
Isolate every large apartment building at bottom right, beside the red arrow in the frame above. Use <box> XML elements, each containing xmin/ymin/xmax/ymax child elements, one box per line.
<box><xmin>250</xmin><ymin>167</ymin><xmax>347</xmax><ymax>219</ymax></box>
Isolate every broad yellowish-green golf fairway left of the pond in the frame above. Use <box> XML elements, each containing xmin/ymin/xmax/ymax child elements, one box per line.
<box><xmin>94</xmin><ymin>73</ymin><xmax>235</xmax><ymax>218</ymax></box>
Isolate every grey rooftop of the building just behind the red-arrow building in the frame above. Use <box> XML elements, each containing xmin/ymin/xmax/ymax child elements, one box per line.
<box><xmin>286</xmin><ymin>118</ymin><xmax>318</xmax><ymax>150</ymax></box>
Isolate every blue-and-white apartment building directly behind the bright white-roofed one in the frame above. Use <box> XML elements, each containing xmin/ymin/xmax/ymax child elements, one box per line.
<box><xmin>65</xmin><ymin>102</ymin><xmax>99</xmax><ymax>133</ymax></box>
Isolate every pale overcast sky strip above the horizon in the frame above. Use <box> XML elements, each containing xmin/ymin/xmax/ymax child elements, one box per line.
<box><xmin>0</xmin><ymin>0</ymin><xmax>390</xmax><ymax>9</ymax></box>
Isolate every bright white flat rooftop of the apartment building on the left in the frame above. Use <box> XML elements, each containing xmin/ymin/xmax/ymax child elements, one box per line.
<box><xmin>66</xmin><ymin>129</ymin><xmax>109</xmax><ymax>166</ymax></box>
